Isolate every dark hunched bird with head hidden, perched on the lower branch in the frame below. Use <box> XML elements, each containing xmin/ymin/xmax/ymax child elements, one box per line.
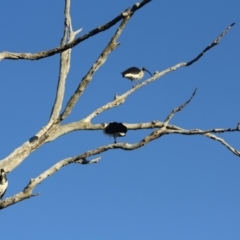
<box><xmin>104</xmin><ymin>122</ymin><xmax>127</xmax><ymax>143</ymax></box>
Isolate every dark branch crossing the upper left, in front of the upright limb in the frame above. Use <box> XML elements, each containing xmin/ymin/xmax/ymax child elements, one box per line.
<box><xmin>0</xmin><ymin>0</ymin><xmax>152</xmax><ymax>60</ymax></box>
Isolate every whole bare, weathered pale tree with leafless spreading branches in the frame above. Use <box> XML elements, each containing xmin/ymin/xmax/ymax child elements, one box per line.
<box><xmin>0</xmin><ymin>0</ymin><xmax>236</xmax><ymax>209</ymax></box>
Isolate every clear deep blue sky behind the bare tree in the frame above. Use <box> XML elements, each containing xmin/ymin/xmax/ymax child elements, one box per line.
<box><xmin>0</xmin><ymin>0</ymin><xmax>240</xmax><ymax>240</ymax></box>
